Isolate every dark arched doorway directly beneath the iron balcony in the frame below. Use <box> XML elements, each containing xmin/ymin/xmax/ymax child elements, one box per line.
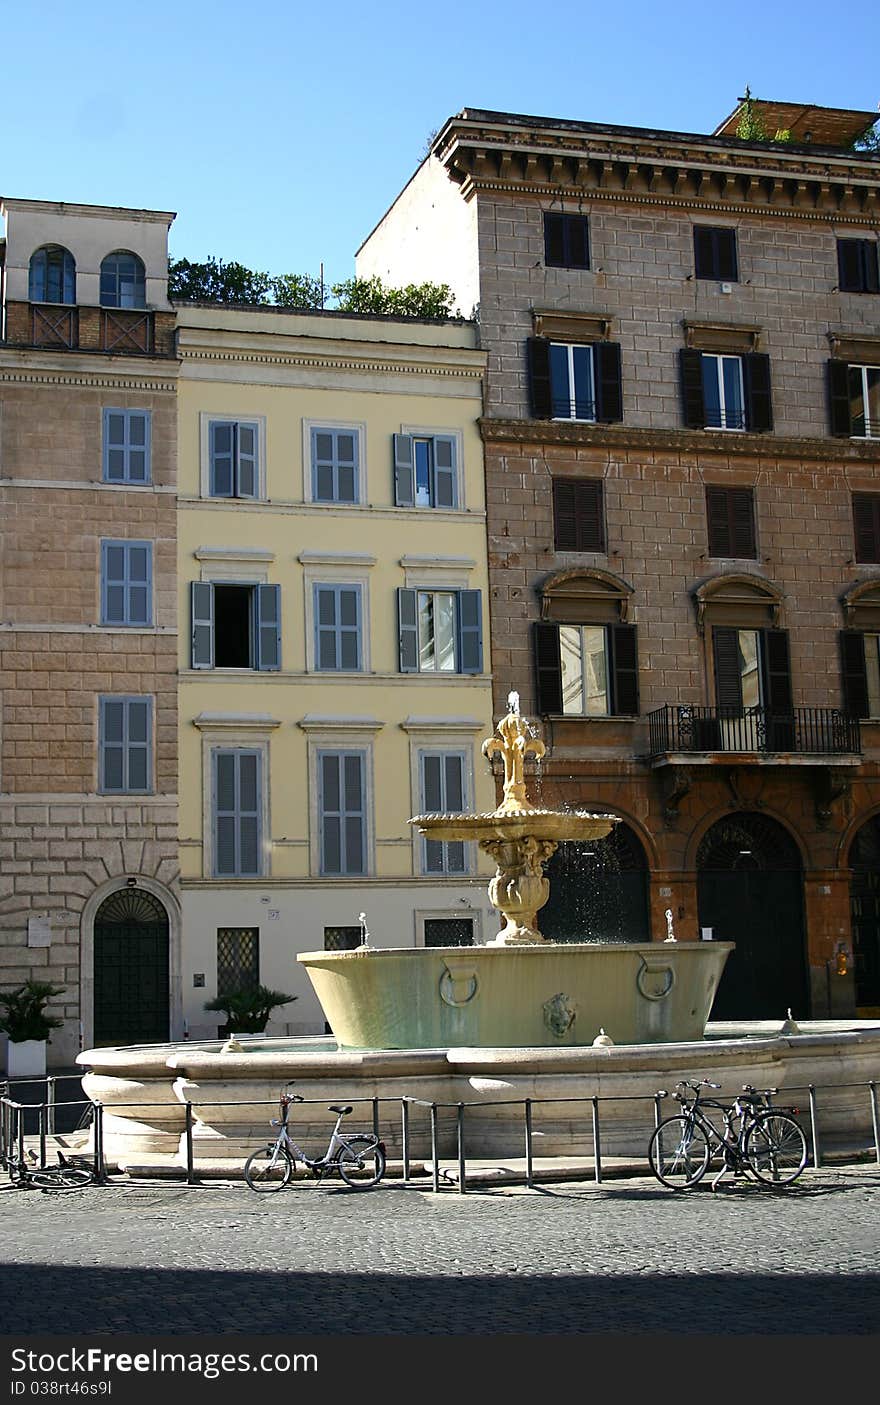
<box><xmin>697</xmin><ymin>812</ymin><xmax>810</xmax><ymax>1020</ymax></box>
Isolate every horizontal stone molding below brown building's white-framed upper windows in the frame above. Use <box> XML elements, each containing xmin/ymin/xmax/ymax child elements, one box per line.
<box><xmin>478</xmin><ymin>419</ymin><xmax>880</xmax><ymax>464</ymax></box>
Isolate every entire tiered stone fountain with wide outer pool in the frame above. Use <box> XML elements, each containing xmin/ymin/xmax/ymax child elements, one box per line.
<box><xmin>77</xmin><ymin>694</ymin><xmax>880</xmax><ymax>1173</ymax></box>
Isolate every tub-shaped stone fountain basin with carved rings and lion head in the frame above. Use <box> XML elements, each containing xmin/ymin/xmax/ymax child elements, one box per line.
<box><xmin>297</xmin><ymin>941</ymin><xmax>734</xmax><ymax>1050</ymax></box>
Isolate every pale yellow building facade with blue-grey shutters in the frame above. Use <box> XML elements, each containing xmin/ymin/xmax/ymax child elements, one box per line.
<box><xmin>177</xmin><ymin>305</ymin><xmax>495</xmax><ymax>1037</ymax></box>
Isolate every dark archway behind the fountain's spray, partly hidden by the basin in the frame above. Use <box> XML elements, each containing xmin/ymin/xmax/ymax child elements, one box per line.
<box><xmin>538</xmin><ymin>822</ymin><xmax>651</xmax><ymax>941</ymax></box>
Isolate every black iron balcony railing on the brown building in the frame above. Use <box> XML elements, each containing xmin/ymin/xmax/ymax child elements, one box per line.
<box><xmin>648</xmin><ymin>705</ymin><xmax>862</xmax><ymax>756</ymax></box>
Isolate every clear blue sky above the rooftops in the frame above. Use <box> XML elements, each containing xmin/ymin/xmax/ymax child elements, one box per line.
<box><xmin>0</xmin><ymin>0</ymin><xmax>880</xmax><ymax>282</ymax></box>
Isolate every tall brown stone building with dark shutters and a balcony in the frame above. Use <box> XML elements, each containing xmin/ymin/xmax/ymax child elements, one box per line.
<box><xmin>357</xmin><ymin>104</ymin><xmax>880</xmax><ymax>1019</ymax></box>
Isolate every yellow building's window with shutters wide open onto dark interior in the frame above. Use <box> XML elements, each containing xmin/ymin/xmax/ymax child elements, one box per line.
<box><xmin>190</xmin><ymin>580</ymin><xmax>281</xmax><ymax>670</ymax></box>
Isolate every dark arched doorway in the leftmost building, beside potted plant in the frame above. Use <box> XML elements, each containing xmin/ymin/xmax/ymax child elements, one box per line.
<box><xmin>94</xmin><ymin>888</ymin><xmax>170</xmax><ymax>1047</ymax></box>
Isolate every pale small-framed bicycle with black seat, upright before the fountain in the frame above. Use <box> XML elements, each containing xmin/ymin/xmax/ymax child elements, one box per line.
<box><xmin>245</xmin><ymin>1083</ymin><xmax>387</xmax><ymax>1191</ymax></box>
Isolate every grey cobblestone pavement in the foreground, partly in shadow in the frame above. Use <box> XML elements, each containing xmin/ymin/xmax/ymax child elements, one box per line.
<box><xmin>0</xmin><ymin>1166</ymin><xmax>880</xmax><ymax>1335</ymax></box>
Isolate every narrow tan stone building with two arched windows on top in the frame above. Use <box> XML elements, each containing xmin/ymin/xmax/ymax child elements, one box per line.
<box><xmin>0</xmin><ymin>200</ymin><xmax>180</xmax><ymax>1066</ymax></box>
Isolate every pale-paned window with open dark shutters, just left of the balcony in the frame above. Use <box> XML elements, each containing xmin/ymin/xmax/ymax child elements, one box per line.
<box><xmin>534</xmin><ymin>621</ymin><xmax>638</xmax><ymax>717</ymax></box>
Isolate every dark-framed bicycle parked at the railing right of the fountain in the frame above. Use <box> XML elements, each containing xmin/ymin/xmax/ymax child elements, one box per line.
<box><xmin>648</xmin><ymin>1079</ymin><xmax>807</xmax><ymax>1190</ymax></box>
